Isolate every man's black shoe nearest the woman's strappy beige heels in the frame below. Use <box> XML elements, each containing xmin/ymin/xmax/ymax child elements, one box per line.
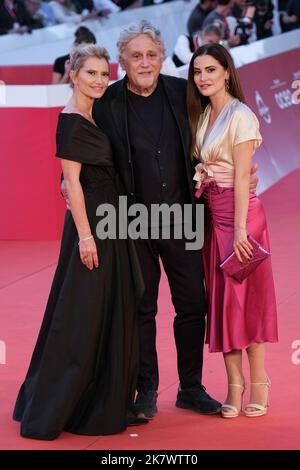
<box><xmin>176</xmin><ymin>384</ymin><xmax>222</xmax><ymax>415</ymax></box>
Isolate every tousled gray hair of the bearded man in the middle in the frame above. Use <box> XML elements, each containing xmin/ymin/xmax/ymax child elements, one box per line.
<box><xmin>117</xmin><ymin>20</ymin><xmax>166</xmax><ymax>60</ymax></box>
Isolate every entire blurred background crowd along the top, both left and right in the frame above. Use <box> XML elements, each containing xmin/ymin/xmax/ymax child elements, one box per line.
<box><xmin>0</xmin><ymin>0</ymin><xmax>300</xmax><ymax>84</ymax></box>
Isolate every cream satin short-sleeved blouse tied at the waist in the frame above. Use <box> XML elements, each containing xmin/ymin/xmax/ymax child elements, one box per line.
<box><xmin>194</xmin><ymin>98</ymin><xmax>262</xmax><ymax>189</ymax></box>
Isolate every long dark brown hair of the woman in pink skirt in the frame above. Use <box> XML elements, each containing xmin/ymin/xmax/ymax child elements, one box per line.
<box><xmin>187</xmin><ymin>44</ymin><xmax>245</xmax><ymax>156</ymax></box>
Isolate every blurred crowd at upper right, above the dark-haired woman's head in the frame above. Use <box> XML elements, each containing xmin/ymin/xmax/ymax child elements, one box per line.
<box><xmin>172</xmin><ymin>0</ymin><xmax>300</xmax><ymax>67</ymax></box>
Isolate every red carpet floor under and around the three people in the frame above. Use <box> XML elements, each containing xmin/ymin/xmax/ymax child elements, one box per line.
<box><xmin>0</xmin><ymin>171</ymin><xmax>300</xmax><ymax>450</ymax></box>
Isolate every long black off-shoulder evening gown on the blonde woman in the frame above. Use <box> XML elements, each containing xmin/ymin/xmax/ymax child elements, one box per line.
<box><xmin>13</xmin><ymin>113</ymin><xmax>143</xmax><ymax>440</ymax></box>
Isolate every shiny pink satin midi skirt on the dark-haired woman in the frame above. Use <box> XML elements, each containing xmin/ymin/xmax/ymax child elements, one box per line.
<box><xmin>203</xmin><ymin>181</ymin><xmax>278</xmax><ymax>352</ymax></box>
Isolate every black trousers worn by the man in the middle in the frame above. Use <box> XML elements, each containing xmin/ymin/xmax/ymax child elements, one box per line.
<box><xmin>136</xmin><ymin>235</ymin><xmax>206</xmax><ymax>392</ymax></box>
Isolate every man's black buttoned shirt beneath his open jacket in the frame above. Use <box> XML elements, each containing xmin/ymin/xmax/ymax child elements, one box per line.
<box><xmin>127</xmin><ymin>81</ymin><xmax>189</xmax><ymax>215</ymax></box>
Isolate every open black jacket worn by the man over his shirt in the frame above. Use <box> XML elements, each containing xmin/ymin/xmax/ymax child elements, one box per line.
<box><xmin>93</xmin><ymin>75</ymin><xmax>195</xmax><ymax>211</ymax></box>
